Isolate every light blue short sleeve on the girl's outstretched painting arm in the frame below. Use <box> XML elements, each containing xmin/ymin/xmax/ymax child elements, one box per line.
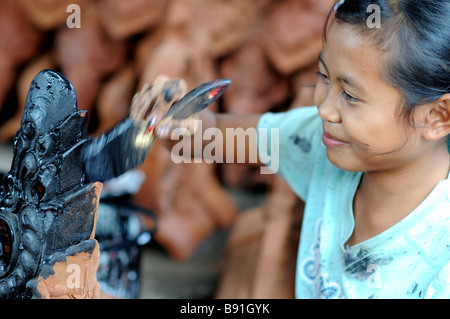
<box><xmin>257</xmin><ymin>107</ymin><xmax>325</xmax><ymax>200</ymax></box>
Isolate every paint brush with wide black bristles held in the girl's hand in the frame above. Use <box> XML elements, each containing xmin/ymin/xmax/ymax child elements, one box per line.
<box><xmin>81</xmin><ymin>79</ymin><xmax>231</xmax><ymax>182</ymax></box>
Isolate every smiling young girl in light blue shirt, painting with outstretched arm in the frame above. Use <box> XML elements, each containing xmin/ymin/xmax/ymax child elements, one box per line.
<box><xmin>128</xmin><ymin>0</ymin><xmax>450</xmax><ymax>298</ymax></box>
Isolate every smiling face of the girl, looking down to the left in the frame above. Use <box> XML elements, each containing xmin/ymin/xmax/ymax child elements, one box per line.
<box><xmin>314</xmin><ymin>22</ymin><xmax>424</xmax><ymax>171</ymax></box>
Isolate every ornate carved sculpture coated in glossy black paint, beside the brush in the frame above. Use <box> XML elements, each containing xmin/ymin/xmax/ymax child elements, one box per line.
<box><xmin>0</xmin><ymin>70</ymin><xmax>148</xmax><ymax>298</ymax></box>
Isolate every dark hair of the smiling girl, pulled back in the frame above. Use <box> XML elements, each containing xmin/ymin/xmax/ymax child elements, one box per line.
<box><xmin>327</xmin><ymin>0</ymin><xmax>450</xmax><ymax>124</ymax></box>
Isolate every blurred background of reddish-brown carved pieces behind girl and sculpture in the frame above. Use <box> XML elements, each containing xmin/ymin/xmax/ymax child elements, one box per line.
<box><xmin>0</xmin><ymin>0</ymin><xmax>334</xmax><ymax>298</ymax></box>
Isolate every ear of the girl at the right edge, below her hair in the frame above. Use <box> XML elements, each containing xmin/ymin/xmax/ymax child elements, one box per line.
<box><xmin>422</xmin><ymin>93</ymin><xmax>450</xmax><ymax>140</ymax></box>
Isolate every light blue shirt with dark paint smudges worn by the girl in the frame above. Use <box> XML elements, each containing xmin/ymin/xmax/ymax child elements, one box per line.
<box><xmin>258</xmin><ymin>107</ymin><xmax>450</xmax><ymax>299</ymax></box>
